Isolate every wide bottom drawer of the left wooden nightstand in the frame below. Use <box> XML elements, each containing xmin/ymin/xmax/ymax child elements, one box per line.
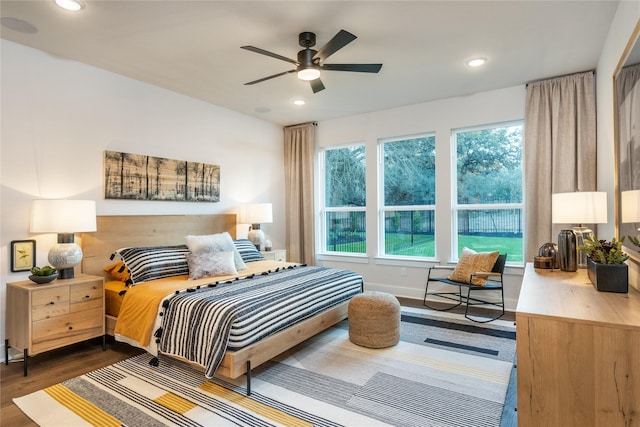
<box><xmin>31</xmin><ymin>307</ymin><xmax>104</xmax><ymax>353</ymax></box>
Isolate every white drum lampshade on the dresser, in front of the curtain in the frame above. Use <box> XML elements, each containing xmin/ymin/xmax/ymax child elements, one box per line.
<box><xmin>551</xmin><ymin>191</ymin><xmax>607</xmax><ymax>224</ymax></box>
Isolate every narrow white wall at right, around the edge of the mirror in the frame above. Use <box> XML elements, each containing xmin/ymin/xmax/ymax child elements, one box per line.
<box><xmin>596</xmin><ymin>0</ymin><xmax>640</xmax><ymax>290</ymax></box>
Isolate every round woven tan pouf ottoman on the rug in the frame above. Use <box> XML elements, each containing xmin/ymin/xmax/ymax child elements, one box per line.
<box><xmin>349</xmin><ymin>292</ymin><xmax>400</xmax><ymax>348</ymax></box>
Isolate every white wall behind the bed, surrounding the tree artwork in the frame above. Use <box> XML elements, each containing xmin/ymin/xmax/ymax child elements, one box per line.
<box><xmin>0</xmin><ymin>40</ymin><xmax>285</xmax><ymax>355</ymax></box>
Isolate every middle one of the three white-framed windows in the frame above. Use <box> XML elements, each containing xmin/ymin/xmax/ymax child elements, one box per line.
<box><xmin>379</xmin><ymin>134</ymin><xmax>436</xmax><ymax>257</ymax></box>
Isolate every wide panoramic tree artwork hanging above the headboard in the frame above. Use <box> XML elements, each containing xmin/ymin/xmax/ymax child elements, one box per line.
<box><xmin>104</xmin><ymin>151</ymin><xmax>220</xmax><ymax>202</ymax></box>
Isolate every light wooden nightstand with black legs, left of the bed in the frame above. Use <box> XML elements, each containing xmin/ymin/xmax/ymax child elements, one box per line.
<box><xmin>5</xmin><ymin>274</ymin><xmax>106</xmax><ymax>377</ymax></box>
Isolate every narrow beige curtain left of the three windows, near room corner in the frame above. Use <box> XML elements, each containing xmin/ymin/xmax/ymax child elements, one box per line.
<box><xmin>284</xmin><ymin>123</ymin><xmax>316</xmax><ymax>265</ymax></box>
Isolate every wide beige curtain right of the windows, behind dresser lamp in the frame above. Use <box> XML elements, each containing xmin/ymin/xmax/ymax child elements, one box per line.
<box><xmin>524</xmin><ymin>71</ymin><xmax>596</xmax><ymax>262</ymax></box>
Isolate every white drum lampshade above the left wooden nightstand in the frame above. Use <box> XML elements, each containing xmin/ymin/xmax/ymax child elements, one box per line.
<box><xmin>30</xmin><ymin>199</ymin><xmax>96</xmax><ymax>233</ymax></box>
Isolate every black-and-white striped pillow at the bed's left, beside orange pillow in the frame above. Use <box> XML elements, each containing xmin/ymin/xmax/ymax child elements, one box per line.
<box><xmin>116</xmin><ymin>245</ymin><xmax>189</xmax><ymax>285</ymax></box>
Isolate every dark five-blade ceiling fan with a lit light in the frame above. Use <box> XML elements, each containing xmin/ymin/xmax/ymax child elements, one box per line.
<box><xmin>241</xmin><ymin>30</ymin><xmax>382</xmax><ymax>93</ymax></box>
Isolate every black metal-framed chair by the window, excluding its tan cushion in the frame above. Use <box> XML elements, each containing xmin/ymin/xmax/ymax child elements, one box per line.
<box><xmin>423</xmin><ymin>254</ymin><xmax>507</xmax><ymax>323</ymax></box>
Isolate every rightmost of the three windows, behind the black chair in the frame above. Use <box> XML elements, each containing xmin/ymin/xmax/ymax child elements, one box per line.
<box><xmin>453</xmin><ymin>122</ymin><xmax>524</xmax><ymax>263</ymax></box>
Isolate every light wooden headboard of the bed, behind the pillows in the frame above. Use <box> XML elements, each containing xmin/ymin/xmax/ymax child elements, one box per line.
<box><xmin>82</xmin><ymin>214</ymin><xmax>236</xmax><ymax>277</ymax></box>
